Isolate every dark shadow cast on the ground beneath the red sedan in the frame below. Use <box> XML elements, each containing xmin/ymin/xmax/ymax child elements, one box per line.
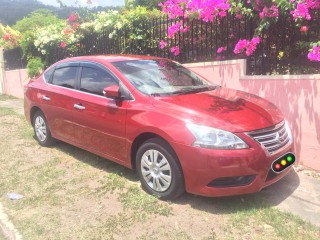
<box><xmin>54</xmin><ymin>142</ymin><xmax>300</xmax><ymax>214</ymax></box>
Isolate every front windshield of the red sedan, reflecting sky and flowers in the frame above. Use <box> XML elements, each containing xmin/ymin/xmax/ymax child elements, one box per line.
<box><xmin>113</xmin><ymin>60</ymin><xmax>217</xmax><ymax>96</ymax></box>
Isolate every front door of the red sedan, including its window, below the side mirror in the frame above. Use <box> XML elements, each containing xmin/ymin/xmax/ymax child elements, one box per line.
<box><xmin>73</xmin><ymin>63</ymin><xmax>127</xmax><ymax>162</ymax></box>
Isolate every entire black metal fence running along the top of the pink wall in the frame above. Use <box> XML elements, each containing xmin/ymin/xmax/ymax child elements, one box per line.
<box><xmin>5</xmin><ymin>12</ymin><xmax>320</xmax><ymax>75</ymax></box>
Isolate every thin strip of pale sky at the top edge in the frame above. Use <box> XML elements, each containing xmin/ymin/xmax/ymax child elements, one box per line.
<box><xmin>38</xmin><ymin>0</ymin><xmax>124</xmax><ymax>7</ymax></box>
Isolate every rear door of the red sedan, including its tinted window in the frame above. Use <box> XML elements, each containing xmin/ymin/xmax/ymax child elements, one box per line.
<box><xmin>39</xmin><ymin>63</ymin><xmax>80</xmax><ymax>143</ymax></box>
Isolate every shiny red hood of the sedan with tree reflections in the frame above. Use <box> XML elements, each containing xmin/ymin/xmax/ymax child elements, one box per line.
<box><xmin>153</xmin><ymin>87</ymin><xmax>284</xmax><ymax>132</ymax></box>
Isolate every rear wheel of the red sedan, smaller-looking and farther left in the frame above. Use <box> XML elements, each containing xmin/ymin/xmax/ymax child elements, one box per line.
<box><xmin>32</xmin><ymin>111</ymin><xmax>55</xmax><ymax>147</ymax></box>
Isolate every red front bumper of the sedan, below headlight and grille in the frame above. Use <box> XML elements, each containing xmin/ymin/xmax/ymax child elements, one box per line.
<box><xmin>172</xmin><ymin>137</ymin><xmax>294</xmax><ymax>197</ymax></box>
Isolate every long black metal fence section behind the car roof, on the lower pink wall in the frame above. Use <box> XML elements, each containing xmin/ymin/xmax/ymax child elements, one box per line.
<box><xmin>50</xmin><ymin>15</ymin><xmax>255</xmax><ymax>69</ymax></box>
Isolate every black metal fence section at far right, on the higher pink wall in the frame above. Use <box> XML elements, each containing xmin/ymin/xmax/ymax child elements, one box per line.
<box><xmin>247</xmin><ymin>11</ymin><xmax>320</xmax><ymax>75</ymax></box>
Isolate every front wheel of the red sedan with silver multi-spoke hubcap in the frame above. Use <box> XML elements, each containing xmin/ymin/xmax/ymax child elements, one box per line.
<box><xmin>136</xmin><ymin>138</ymin><xmax>185</xmax><ymax>200</ymax></box>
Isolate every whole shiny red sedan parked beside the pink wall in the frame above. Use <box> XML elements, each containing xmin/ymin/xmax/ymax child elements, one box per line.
<box><xmin>24</xmin><ymin>55</ymin><xmax>294</xmax><ymax>199</ymax></box>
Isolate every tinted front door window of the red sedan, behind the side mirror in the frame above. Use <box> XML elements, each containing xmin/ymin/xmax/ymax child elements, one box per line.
<box><xmin>80</xmin><ymin>67</ymin><xmax>118</xmax><ymax>96</ymax></box>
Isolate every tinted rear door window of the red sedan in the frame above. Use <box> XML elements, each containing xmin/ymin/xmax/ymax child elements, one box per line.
<box><xmin>52</xmin><ymin>67</ymin><xmax>77</xmax><ymax>88</ymax></box>
